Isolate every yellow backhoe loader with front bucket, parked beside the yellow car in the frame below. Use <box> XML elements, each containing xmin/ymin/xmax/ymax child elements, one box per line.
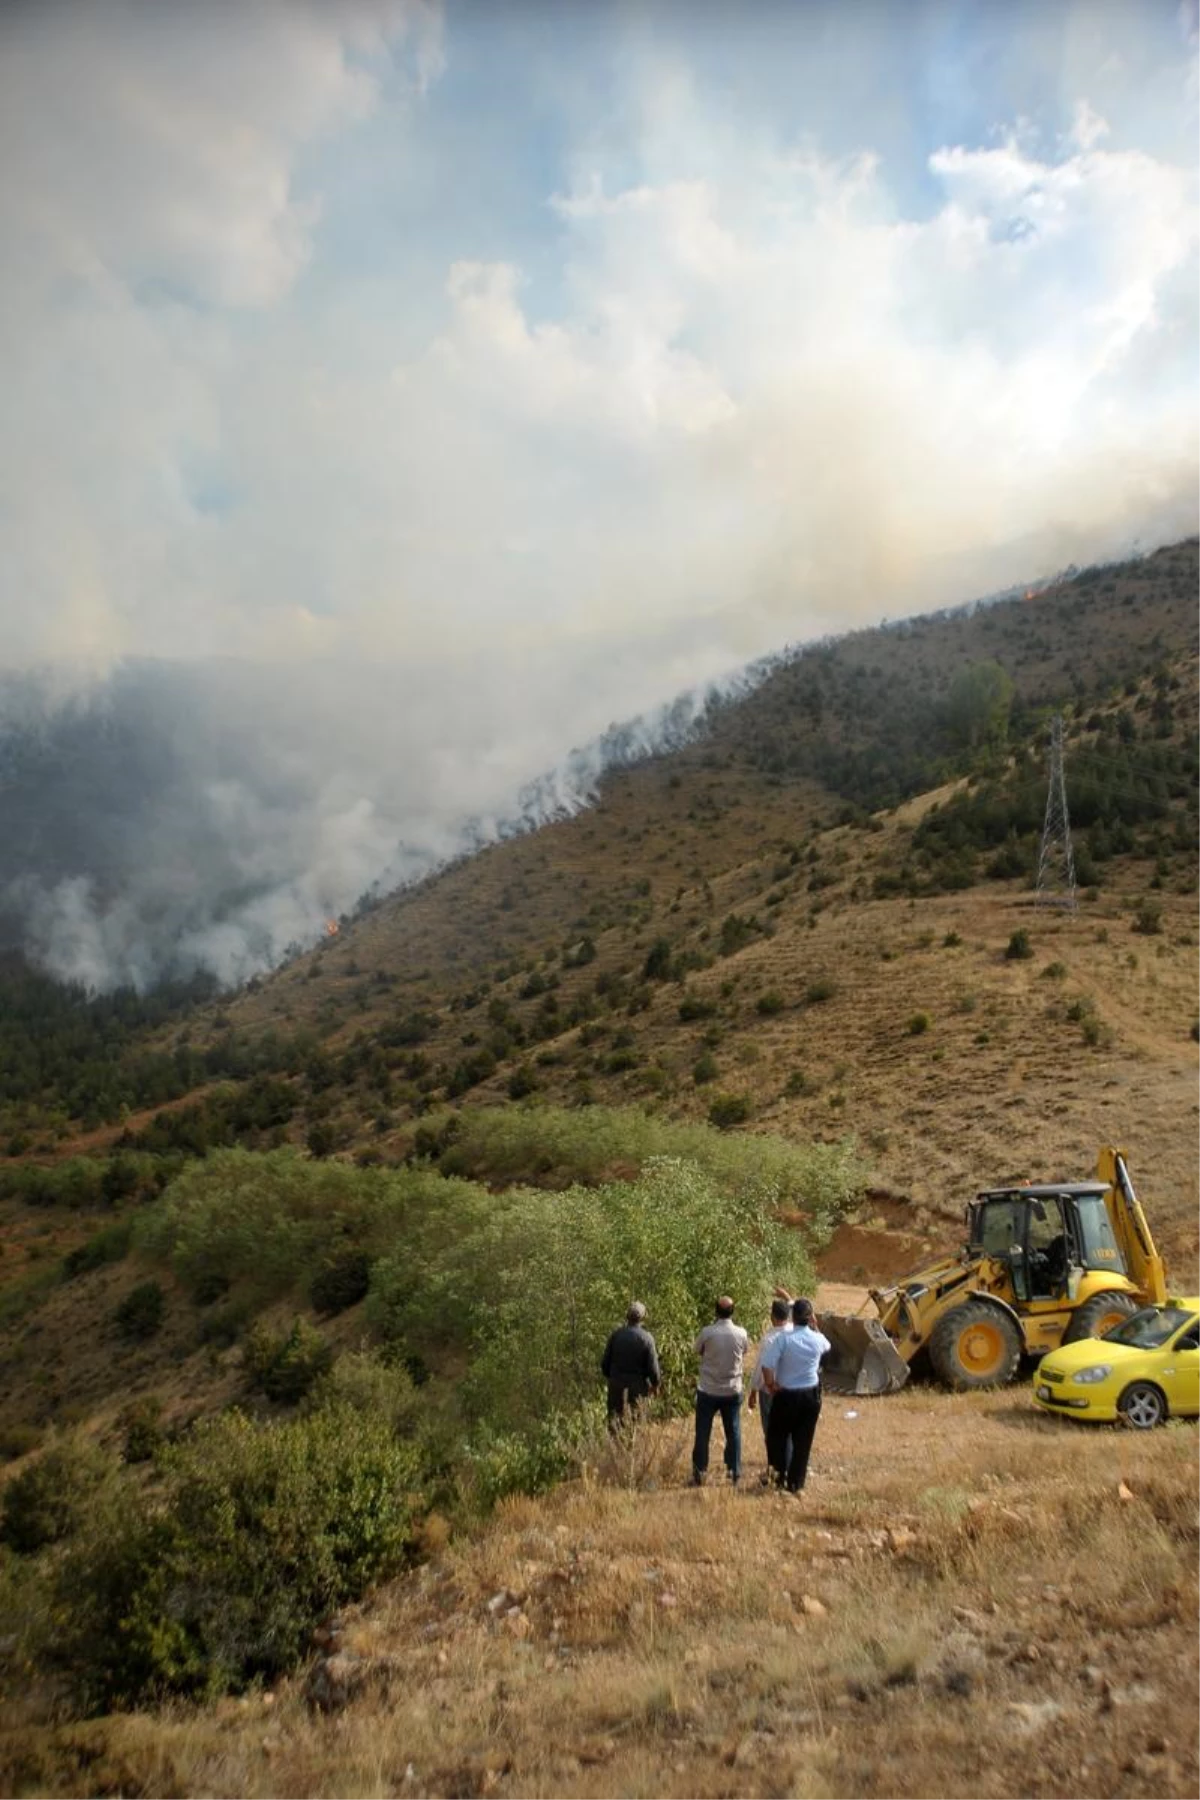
<box><xmin>820</xmin><ymin>1148</ymin><xmax>1166</xmax><ymax>1393</ymax></box>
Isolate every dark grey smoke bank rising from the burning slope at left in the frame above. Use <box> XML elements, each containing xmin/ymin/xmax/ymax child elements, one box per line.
<box><xmin>0</xmin><ymin>648</ymin><xmax>759</xmax><ymax>990</ymax></box>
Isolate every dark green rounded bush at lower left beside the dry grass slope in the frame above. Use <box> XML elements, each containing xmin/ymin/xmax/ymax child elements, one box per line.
<box><xmin>58</xmin><ymin>1406</ymin><xmax>421</xmax><ymax>1706</ymax></box>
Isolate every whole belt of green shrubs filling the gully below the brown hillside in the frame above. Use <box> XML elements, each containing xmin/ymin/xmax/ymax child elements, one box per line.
<box><xmin>0</xmin><ymin>1109</ymin><xmax>862</xmax><ymax>1706</ymax></box>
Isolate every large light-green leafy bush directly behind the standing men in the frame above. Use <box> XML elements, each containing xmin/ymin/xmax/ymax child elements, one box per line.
<box><xmin>367</xmin><ymin>1147</ymin><xmax>816</xmax><ymax>1436</ymax></box>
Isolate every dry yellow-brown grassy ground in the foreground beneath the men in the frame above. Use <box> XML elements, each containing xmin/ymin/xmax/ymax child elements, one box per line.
<box><xmin>0</xmin><ymin>1391</ymin><xmax>1200</xmax><ymax>1800</ymax></box>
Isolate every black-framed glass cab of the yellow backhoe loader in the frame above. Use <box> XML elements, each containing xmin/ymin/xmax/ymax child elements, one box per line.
<box><xmin>966</xmin><ymin>1181</ymin><xmax>1126</xmax><ymax>1303</ymax></box>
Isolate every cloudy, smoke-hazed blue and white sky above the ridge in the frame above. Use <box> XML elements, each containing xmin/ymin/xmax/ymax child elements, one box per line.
<box><xmin>0</xmin><ymin>0</ymin><xmax>1200</xmax><ymax>970</ymax></box>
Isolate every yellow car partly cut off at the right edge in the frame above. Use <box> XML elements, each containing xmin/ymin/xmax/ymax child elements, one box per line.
<box><xmin>1033</xmin><ymin>1298</ymin><xmax>1200</xmax><ymax>1431</ymax></box>
